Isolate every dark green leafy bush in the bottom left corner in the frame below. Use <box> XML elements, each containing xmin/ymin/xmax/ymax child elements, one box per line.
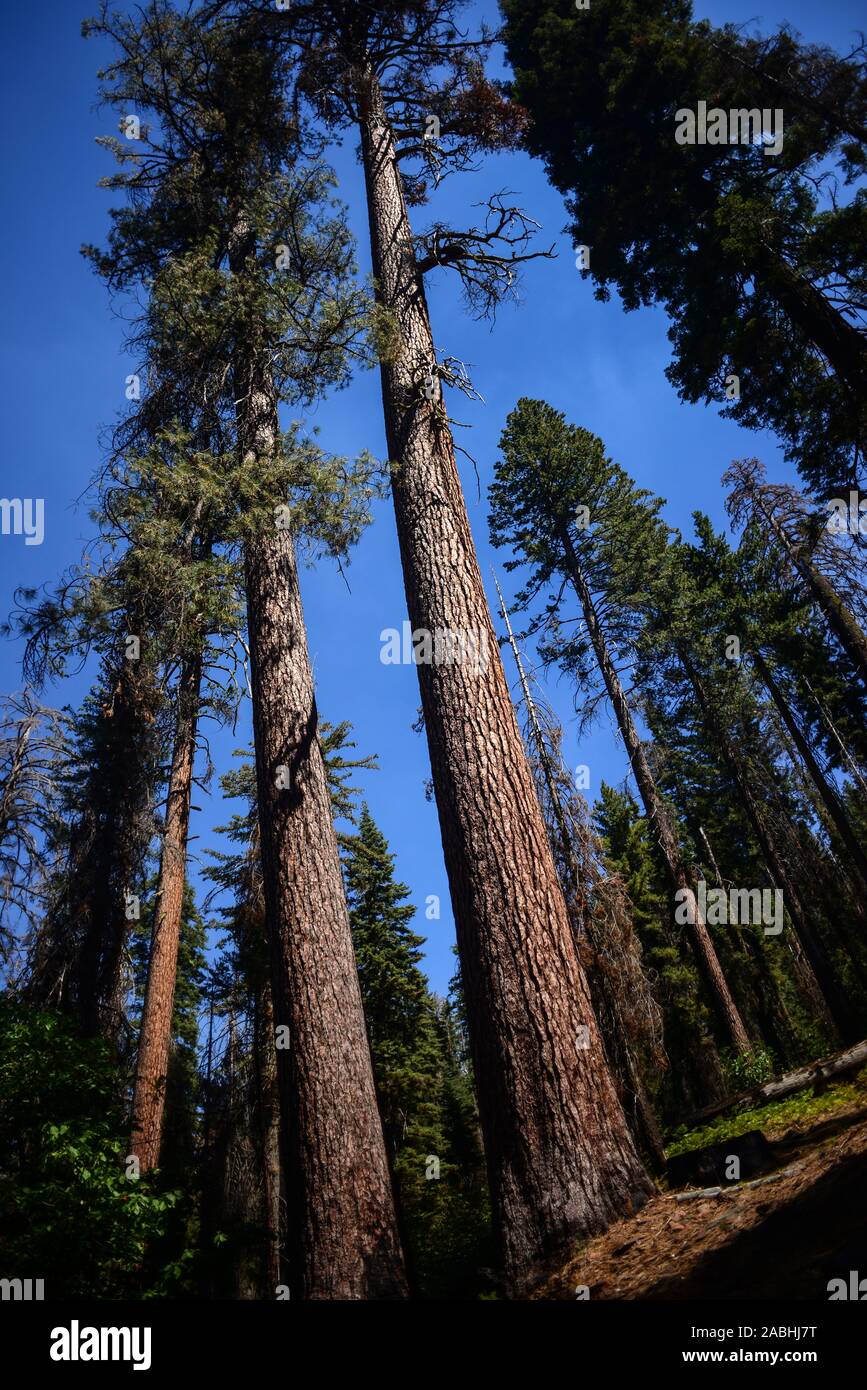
<box><xmin>0</xmin><ymin>1001</ymin><xmax>181</xmax><ymax>1298</ymax></box>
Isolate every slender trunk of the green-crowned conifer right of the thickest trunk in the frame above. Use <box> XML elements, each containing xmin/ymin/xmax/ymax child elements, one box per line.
<box><xmin>560</xmin><ymin>527</ymin><xmax>750</xmax><ymax>1052</ymax></box>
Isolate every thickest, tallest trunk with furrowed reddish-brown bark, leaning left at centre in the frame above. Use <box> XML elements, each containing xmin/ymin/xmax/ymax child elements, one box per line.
<box><xmin>354</xmin><ymin>71</ymin><xmax>650</xmax><ymax>1287</ymax></box>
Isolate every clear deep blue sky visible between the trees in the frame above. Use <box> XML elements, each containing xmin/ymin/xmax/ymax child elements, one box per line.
<box><xmin>0</xmin><ymin>0</ymin><xmax>863</xmax><ymax>991</ymax></box>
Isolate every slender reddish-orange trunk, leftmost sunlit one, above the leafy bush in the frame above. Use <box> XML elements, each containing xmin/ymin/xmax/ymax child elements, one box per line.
<box><xmin>131</xmin><ymin>655</ymin><xmax>201</xmax><ymax>1173</ymax></box>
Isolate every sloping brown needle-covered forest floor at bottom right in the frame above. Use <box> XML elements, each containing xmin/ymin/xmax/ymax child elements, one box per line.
<box><xmin>529</xmin><ymin>1072</ymin><xmax>867</xmax><ymax>1301</ymax></box>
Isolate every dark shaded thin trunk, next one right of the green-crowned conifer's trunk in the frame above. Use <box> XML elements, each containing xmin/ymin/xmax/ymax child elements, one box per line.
<box><xmin>678</xmin><ymin>649</ymin><xmax>860</xmax><ymax>1043</ymax></box>
